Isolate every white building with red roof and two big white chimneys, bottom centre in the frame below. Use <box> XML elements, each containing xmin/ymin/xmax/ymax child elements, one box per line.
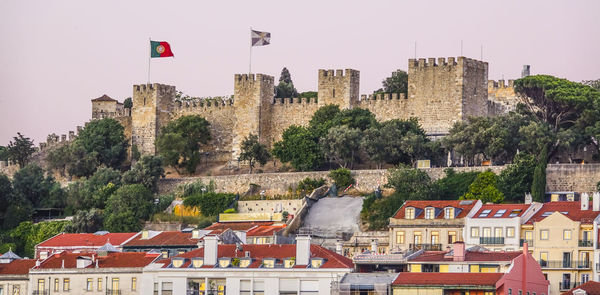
<box><xmin>141</xmin><ymin>236</ymin><xmax>353</xmax><ymax>295</ymax></box>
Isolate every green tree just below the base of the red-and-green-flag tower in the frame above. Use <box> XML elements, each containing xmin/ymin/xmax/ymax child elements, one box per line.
<box><xmin>123</xmin><ymin>156</ymin><xmax>165</xmax><ymax>193</ymax></box>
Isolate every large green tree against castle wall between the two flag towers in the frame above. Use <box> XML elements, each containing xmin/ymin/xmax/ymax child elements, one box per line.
<box><xmin>156</xmin><ymin>115</ymin><xmax>211</xmax><ymax>174</ymax></box>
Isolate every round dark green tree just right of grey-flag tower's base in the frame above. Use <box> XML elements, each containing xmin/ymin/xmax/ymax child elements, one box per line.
<box><xmin>272</xmin><ymin>125</ymin><xmax>323</xmax><ymax>171</ymax></box>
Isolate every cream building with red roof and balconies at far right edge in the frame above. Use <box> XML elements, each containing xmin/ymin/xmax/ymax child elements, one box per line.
<box><xmin>521</xmin><ymin>199</ymin><xmax>600</xmax><ymax>294</ymax></box>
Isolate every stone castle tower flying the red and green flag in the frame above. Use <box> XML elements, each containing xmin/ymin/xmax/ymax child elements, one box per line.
<box><xmin>131</xmin><ymin>83</ymin><xmax>175</xmax><ymax>155</ymax></box>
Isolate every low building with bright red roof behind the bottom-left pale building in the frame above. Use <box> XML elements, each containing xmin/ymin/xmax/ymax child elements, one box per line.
<box><xmin>35</xmin><ymin>231</ymin><xmax>138</xmax><ymax>259</ymax></box>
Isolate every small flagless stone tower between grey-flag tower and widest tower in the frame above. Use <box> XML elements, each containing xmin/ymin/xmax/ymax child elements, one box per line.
<box><xmin>318</xmin><ymin>69</ymin><xmax>360</xmax><ymax>109</ymax></box>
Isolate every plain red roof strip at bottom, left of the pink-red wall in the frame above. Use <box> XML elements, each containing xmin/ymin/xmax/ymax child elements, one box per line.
<box><xmin>392</xmin><ymin>272</ymin><xmax>504</xmax><ymax>289</ymax></box>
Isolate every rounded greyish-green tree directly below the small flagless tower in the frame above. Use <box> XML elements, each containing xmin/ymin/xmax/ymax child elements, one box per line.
<box><xmin>321</xmin><ymin>125</ymin><xmax>362</xmax><ymax>169</ymax></box>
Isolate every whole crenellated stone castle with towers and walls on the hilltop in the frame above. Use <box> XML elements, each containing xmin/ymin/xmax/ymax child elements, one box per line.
<box><xmin>92</xmin><ymin>57</ymin><xmax>517</xmax><ymax>161</ymax></box>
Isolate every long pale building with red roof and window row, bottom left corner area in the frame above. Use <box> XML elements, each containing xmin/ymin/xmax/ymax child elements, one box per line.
<box><xmin>28</xmin><ymin>250</ymin><xmax>160</xmax><ymax>295</ymax></box>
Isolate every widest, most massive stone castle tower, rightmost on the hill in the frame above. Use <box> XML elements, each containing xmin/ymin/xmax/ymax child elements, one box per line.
<box><xmin>408</xmin><ymin>57</ymin><xmax>488</xmax><ymax>135</ymax></box>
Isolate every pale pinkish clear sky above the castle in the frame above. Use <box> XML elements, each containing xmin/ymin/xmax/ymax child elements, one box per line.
<box><xmin>0</xmin><ymin>0</ymin><xmax>600</xmax><ymax>146</ymax></box>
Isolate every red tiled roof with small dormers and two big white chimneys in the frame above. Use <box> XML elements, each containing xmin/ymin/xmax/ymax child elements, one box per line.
<box><xmin>158</xmin><ymin>244</ymin><xmax>354</xmax><ymax>268</ymax></box>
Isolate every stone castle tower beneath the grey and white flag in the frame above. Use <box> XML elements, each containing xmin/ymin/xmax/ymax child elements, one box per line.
<box><xmin>232</xmin><ymin>74</ymin><xmax>275</xmax><ymax>159</ymax></box>
